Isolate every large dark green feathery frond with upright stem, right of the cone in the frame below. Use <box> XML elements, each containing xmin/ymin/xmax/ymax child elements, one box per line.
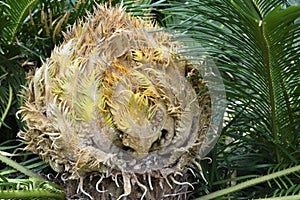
<box><xmin>164</xmin><ymin>0</ymin><xmax>300</xmax><ymax>162</ymax></box>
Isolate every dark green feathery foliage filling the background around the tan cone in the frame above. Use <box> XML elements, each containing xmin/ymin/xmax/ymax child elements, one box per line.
<box><xmin>0</xmin><ymin>0</ymin><xmax>300</xmax><ymax>199</ymax></box>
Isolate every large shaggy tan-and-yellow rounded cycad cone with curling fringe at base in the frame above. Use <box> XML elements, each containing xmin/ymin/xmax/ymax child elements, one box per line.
<box><xmin>19</xmin><ymin>3</ymin><xmax>211</xmax><ymax>199</ymax></box>
